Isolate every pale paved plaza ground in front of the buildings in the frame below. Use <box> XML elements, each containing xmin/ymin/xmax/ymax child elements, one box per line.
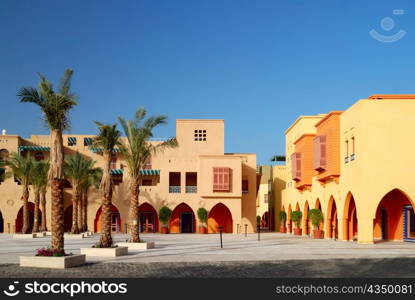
<box><xmin>0</xmin><ymin>233</ymin><xmax>415</xmax><ymax>278</ymax></box>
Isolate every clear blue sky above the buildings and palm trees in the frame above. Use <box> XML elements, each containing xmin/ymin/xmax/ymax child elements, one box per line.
<box><xmin>0</xmin><ymin>0</ymin><xmax>415</xmax><ymax>163</ymax></box>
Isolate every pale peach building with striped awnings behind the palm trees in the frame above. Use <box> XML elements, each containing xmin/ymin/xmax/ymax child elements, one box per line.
<box><xmin>0</xmin><ymin>120</ymin><xmax>257</xmax><ymax>233</ymax></box>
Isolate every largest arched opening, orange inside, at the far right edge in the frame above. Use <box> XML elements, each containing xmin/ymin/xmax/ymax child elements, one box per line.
<box><xmin>373</xmin><ymin>189</ymin><xmax>415</xmax><ymax>241</ymax></box>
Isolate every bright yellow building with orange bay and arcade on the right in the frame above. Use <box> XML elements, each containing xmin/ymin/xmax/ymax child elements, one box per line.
<box><xmin>274</xmin><ymin>95</ymin><xmax>415</xmax><ymax>243</ymax></box>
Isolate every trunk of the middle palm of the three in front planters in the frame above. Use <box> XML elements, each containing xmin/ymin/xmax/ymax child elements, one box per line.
<box><xmin>100</xmin><ymin>152</ymin><xmax>112</xmax><ymax>248</ymax></box>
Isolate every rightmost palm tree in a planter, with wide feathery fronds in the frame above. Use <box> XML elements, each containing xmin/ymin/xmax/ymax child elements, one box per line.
<box><xmin>118</xmin><ymin>108</ymin><xmax>178</xmax><ymax>243</ymax></box>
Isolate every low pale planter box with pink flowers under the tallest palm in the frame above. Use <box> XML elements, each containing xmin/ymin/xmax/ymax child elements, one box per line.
<box><xmin>20</xmin><ymin>255</ymin><xmax>85</xmax><ymax>269</ymax></box>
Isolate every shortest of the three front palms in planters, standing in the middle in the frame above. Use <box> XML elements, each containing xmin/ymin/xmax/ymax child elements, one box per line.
<box><xmin>92</xmin><ymin>122</ymin><xmax>123</xmax><ymax>248</ymax></box>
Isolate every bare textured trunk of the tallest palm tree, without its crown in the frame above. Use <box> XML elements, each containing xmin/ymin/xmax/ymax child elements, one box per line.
<box><xmin>49</xmin><ymin>130</ymin><xmax>65</xmax><ymax>251</ymax></box>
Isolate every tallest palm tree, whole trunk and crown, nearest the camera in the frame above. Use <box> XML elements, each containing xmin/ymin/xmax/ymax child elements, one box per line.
<box><xmin>17</xmin><ymin>69</ymin><xmax>77</xmax><ymax>251</ymax></box>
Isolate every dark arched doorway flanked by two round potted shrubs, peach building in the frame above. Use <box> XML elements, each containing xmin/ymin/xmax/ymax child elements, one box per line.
<box><xmin>170</xmin><ymin>203</ymin><xmax>196</xmax><ymax>233</ymax></box>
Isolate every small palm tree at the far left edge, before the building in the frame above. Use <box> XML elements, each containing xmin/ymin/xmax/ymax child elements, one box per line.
<box><xmin>2</xmin><ymin>153</ymin><xmax>35</xmax><ymax>233</ymax></box>
